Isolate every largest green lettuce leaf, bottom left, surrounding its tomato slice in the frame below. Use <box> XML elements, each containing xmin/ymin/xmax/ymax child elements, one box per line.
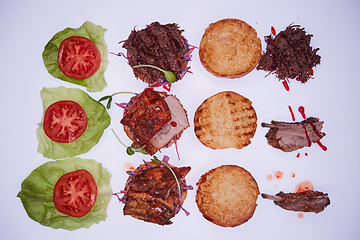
<box><xmin>17</xmin><ymin>157</ymin><xmax>112</xmax><ymax>230</ymax></box>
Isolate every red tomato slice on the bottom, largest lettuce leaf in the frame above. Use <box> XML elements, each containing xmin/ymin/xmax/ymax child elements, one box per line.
<box><xmin>53</xmin><ymin>169</ymin><xmax>97</xmax><ymax>218</ymax></box>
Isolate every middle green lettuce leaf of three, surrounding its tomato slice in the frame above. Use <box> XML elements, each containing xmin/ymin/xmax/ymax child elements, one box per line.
<box><xmin>36</xmin><ymin>86</ymin><xmax>111</xmax><ymax>159</ymax></box>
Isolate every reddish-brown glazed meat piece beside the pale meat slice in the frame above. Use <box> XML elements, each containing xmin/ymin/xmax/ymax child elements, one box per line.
<box><xmin>120</xmin><ymin>88</ymin><xmax>171</xmax><ymax>147</ymax></box>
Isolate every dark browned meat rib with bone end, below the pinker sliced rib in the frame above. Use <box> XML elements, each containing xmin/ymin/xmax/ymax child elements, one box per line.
<box><xmin>261</xmin><ymin>190</ymin><xmax>330</xmax><ymax>213</ymax></box>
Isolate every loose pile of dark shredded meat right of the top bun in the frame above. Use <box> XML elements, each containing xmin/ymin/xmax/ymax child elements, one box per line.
<box><xmin>256</xmin><ymin>25</ymin><xmax>321</xmax><ymax>83</ymax></box>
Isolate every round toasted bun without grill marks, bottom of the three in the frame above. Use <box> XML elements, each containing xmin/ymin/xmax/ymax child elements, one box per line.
<box><xmin>195</xmin><ymin>165</ymin><xmax>260</xmax><ymax>227</ymax></box>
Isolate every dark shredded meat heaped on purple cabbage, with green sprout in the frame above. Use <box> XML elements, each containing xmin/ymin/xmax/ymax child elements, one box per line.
<box><xmin>123</xmin><ymin>22</ymin><xmax>190</xmax><ymax>84</ymax></box>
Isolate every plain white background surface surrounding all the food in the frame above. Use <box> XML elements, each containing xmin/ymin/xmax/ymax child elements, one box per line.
<box><xmin>0</xmin><ymin>0</ymin><xmax>360</xmax><ymax>240</ymax></box>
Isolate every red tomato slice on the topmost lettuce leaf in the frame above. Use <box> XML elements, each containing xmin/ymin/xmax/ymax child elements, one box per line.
<box><xmin>57</xmin><ymin>36</ymin><xmax>101</xmax><ymax>80</ymax></box>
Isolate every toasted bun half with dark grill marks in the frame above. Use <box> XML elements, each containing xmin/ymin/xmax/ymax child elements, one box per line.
<box><xmin>194</xmin><ymin>91</ymin><xmax>257</xmax><ymax>149</ymax></box>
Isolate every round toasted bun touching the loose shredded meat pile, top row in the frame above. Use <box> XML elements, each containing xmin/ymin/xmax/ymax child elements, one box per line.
<box><xmin>199</xmin><ymin>18</ymin><xmax>261</xmax><ymax>78</ymax></box>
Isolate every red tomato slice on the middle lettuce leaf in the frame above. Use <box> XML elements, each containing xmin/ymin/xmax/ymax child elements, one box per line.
<box><xmin>43</xmin><ymin>100</ymin><xmax>88</xmax><ymax>143</ymax></box>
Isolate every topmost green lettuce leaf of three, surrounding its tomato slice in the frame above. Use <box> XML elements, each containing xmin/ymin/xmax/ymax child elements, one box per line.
<box><xmin>42</xmin><ymin>21</ymin><xmax>108</xmax><ymax>92</ymax></box>
